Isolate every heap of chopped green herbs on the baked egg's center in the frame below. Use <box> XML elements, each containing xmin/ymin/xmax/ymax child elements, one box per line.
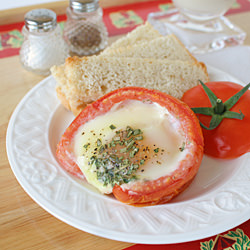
<box><xmin>84</xmin><ymin>124</ymin><xmax>149</xmax><ymax>186</ymax></box>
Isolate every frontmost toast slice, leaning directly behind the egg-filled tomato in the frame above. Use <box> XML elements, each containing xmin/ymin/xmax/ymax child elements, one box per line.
<box><xmin>51</xmin><ymin>56</ymin><xmax>208</xmax><ymax>115</ymax></box>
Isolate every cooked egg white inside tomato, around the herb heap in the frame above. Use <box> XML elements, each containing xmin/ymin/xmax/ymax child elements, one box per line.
<box><xmin>74</xmin><ymin>100</ymin><xmax>187</xmax><ymax>193</ymax></box>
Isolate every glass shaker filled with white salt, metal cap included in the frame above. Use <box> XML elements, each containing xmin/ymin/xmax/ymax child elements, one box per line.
<box><xmin>20</xmin><ymin>9</ymin><xmax>69</xmax><ymax>75</ymax></box>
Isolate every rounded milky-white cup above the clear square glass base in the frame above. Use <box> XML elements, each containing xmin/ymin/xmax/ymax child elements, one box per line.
<box><xmin>173</xmin><ymin>0</ymin><xmax>235</xmax><ymax>21</ymax></box>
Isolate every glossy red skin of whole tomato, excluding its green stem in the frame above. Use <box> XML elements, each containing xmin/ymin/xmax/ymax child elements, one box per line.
<box><xmin>182</xmin><ymin>82</ymin><xmax>250</xmax><ymax>159</ymax></box>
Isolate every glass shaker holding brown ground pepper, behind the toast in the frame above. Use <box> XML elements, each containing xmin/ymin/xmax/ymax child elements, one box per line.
<box><xmin>64</xmin><ymin>0</ymin><xmax>108</xmax><ymax>56</ymax></box>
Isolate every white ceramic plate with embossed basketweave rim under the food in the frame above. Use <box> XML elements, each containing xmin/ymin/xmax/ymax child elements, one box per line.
<box><xmin>7</xmin><ymin>67</ymin><xmax>250</xmax><ymax>244</ymax></box>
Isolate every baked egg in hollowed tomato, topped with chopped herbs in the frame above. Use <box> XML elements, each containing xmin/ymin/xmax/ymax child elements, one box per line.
<box><xmin>57</xmin><ymin>87</ymin><xmax>203</xmax><ymax>206</ymax></box>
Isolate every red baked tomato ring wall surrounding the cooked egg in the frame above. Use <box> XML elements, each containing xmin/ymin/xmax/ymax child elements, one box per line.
<box><xmin>57</xmin><ymin>87</ymin><xmax>204</xmax><ymax>206</ymax></box>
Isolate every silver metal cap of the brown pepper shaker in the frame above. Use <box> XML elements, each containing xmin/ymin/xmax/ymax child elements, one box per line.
<box><xmin>70</xmin><ymin>0</ymin><xmax>99</xmax><ymax>12</ymax></box>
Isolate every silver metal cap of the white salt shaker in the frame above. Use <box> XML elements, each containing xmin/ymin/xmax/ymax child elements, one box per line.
<box><xmin>24</xmin><ymin>9</ymin><xmax>57</xmax><ymax>32</ymax></box>
